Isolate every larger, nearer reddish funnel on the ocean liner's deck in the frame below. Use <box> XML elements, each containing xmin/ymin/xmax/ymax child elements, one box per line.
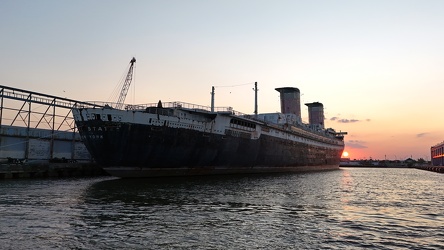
<box><xmin>276</xmin><ymin>87</ymin><xmax>301</xmax><ymax>120</ymax></box>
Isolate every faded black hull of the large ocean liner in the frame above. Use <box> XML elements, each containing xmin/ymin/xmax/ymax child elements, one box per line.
<box><xmin>77</xmin><ymin>120</ymin><xmax>342</xmax><ymax>177</ymax></box>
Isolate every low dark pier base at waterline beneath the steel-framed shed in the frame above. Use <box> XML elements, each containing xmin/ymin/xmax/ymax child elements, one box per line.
<box><xmin>0</xmin><ymin>163</ymin><xmax>107</xmax><ymax>180</ymax></box>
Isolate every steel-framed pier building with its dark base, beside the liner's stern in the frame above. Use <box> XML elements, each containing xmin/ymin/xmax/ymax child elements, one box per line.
<box><xmin>0</xmin><ymin>85</ymin><xmax>102</xmax><ymax>179</ymax></box>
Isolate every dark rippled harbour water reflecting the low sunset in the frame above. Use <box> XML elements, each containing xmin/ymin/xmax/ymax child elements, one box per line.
<box><xmin>0</xmin><ymin>168</ymin><xmax>444</xmax><ymax>249</ymax></box>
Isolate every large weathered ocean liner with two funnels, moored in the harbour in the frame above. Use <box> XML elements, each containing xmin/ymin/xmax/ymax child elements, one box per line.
<box><xmin>73</xmin><ymin>59</ymin><xmax>346</xmax><ymax>178</ymax></box>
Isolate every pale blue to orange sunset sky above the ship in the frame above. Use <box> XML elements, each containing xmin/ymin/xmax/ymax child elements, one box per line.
<box><xmin>0</xmin><ymin>0</ymin><xmax>444</xmax><ymax>160</ymax></box>
